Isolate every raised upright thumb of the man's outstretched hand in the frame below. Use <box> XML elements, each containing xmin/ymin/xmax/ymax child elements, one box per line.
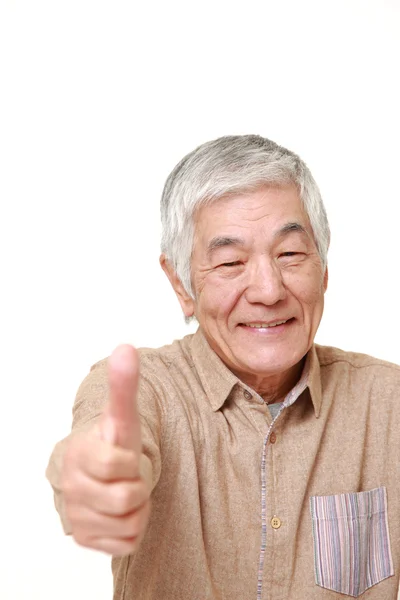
<box><xmin>100</xmin><ymin>344</ymin><xmax>142</xmax><ymax>455</ymax></box>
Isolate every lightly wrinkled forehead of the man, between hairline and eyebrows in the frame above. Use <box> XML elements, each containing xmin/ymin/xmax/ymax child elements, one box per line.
<box><xmin>195</xmin><ymin>185</ymin><xmax>311</xmax><ymax>242</ymax></box>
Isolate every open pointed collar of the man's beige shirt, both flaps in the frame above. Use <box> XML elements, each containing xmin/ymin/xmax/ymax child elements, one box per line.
<box><xmin>191</xmin><ymin>327</ymin><xmax>322</xmax><ymax>417</ymax></box>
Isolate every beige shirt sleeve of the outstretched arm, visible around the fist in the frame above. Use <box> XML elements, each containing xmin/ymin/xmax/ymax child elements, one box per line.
<box><xmin>46</xmin><ymin>359</ymin><xmax>165</xmax><ymax>535</ymax></box>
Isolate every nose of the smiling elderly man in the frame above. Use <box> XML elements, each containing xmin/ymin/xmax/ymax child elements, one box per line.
<box><xmin>245</xmin><ymin>258</ymin><xmax>287</xmax><ymax>306</ymax></box>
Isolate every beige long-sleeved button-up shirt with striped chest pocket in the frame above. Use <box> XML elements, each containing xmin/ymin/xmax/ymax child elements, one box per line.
<box><xmin>47</xmin><ymin>330</ymin><xmax>400</xmax><ymax>600</ymax></box>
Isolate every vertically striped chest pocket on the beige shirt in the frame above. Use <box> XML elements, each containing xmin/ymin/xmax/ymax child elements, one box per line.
<box><xmin>310</xmin><ymin>487</ymin><xmax>394</xmax><ymax>598</ymax></box>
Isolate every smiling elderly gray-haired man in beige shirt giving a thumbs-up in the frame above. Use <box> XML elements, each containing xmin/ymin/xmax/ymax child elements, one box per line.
<box><xmin>47</xmin><ymin>135</ymin><xmax>400</xmax><ymax>600</ymax></box>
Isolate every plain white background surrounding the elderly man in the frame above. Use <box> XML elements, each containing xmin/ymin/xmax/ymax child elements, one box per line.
<box><xmin>0</xmin><ymin>0</ymin><xmax>400</xmax><ymax>600</ymax></box>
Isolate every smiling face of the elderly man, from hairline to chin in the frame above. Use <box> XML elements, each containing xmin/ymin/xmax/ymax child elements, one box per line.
<box><xmin>164</xmin><ymin>185</ymin><xmax>327</xmax><ymax>381</ymax></box>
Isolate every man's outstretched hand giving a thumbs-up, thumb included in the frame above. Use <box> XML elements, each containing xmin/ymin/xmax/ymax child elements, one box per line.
<box><xmin>61</xmin><ymin>345</ymin><xmax>150</xmax><ymax>556</ymax></box>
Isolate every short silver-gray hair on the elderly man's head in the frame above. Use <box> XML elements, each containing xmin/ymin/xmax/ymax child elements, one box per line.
<box><xmin>161</xmin><ymin>135</ymin><xmax>330</xmax><ymax>297</ymax></box>
